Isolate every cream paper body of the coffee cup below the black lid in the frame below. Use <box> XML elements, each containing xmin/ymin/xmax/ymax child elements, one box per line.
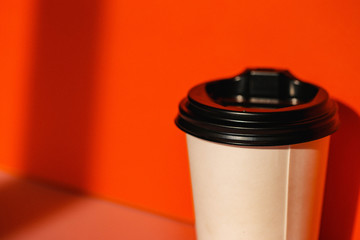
<box><xmin>186</xmin><ymin>134</ymin><xmax>330</xmax><ymax>240</ymax></box>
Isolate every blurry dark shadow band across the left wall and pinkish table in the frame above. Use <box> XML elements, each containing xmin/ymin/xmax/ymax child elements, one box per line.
<box><xmin>0</xmin><ymin>0</ymin><xmax>101</xmax><ymax>236</ymax></box>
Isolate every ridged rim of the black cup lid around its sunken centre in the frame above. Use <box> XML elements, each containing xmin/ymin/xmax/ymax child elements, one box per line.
<box><xmin>175</xmin><ymin>70</ymin><xmax>339</xmax><ymax>146</ymax></box>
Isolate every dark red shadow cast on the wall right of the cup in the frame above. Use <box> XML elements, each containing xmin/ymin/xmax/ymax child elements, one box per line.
<box><xmin>320</xmin><ymin>102</ymin><xmax>360</xmax><ymax>240</ymax></box>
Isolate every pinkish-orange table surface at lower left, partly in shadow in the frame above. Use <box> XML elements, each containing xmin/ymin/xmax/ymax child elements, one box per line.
<box><xmin>0</xmin><ymin>171</ymin><xmax>195</xmax><ymax>240</ymax></box>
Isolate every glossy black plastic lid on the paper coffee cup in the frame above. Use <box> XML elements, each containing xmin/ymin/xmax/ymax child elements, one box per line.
<box><xmin>175</xmin><ymin>69</ymin><xmax>339</xmax><ymax>146</ymax></box>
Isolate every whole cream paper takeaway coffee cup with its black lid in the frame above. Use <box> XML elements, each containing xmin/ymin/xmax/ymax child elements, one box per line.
<box><xmin>175</xmin><ymin>69</ymin><xmax>339</xmax><ymax>240</ymax></box>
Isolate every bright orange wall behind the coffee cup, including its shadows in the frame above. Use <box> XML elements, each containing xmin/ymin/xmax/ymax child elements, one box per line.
<box><xmin>0</xmin><ymin>0</ymin><xmax>360</xmax><ymax>240</ymax></box>
